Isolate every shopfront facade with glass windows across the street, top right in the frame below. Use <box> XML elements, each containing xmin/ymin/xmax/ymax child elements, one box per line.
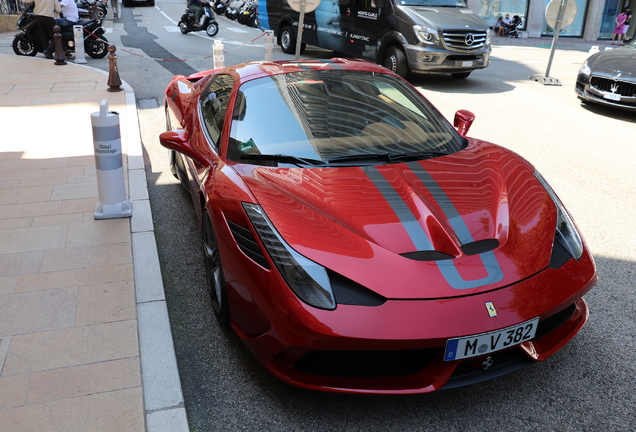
<box><xmin>467</xmin><ymin>0</ymin><xmax>636</xmax><ymax>41</ymax></box>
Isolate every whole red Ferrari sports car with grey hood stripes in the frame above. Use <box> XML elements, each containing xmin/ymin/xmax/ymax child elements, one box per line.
<box><xmin>160</xmin><ymin>59</ymin><xmax>597</xmax><ymax>393</ymax></box>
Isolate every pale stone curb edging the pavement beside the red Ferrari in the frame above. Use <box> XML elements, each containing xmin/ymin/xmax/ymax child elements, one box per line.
<box><xmin>76</xmin><ymin>64</ymin><xmax>189</xmax><ymax>432</ymax></box>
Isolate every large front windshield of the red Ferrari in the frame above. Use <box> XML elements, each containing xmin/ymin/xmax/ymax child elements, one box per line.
<box><xmin>227</xmin><ymin>70</ymin><xmax>466</xmax><ymax>166</ymax></box>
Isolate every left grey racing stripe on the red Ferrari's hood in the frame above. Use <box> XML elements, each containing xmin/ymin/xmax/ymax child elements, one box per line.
<box><xmin>363</xmin><ymin>167</ymin><xmax>433</xmax><ymax>251</ymax></box>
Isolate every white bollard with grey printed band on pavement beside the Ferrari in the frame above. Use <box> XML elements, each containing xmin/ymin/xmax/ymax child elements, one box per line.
<box><xmin>91</xmin><ymin>99</ymin><xmax>132</xmax><ymax>219</ymax></box>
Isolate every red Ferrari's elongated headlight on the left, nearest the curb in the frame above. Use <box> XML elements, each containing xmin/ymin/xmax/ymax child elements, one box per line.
<box><xmin>243</xmin><ymin>203</ymin><xmax>336</xmax><ymax>310</ymax></box>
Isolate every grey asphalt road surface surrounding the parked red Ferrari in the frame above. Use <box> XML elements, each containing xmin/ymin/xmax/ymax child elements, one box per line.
<box><xmin>0</xmin><ymin>5</ymin><xmax>636</xmax><ymax>431</ymax></box>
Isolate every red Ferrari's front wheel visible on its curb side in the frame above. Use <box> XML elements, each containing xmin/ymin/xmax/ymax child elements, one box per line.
<box><xmin>201</xmin><ymin>210</ymin><xmax>230</xmax><ymax>324</ymax></box>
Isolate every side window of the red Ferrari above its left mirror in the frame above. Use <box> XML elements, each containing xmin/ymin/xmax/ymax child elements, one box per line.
<box><xmin>200</xmin><ymin>75</ymin><xmax>234</xmax><ymax>151</ymax></box>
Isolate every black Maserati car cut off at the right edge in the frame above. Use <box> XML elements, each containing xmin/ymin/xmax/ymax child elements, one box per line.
<box><xmin>576</xmin><ymin>39</ymin><xmax>636</xmax><ymax>111</ymax></box>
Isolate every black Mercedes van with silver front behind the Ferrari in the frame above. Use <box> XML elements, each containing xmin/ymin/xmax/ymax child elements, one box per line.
<box><xmin>258</xmin><ymin>0</ymin><xmax>491</xmax><ymax>78</ymax></box>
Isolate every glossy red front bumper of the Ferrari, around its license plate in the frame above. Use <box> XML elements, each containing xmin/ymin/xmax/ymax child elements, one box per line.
<box><xmin>239</xmin><ymin>254</ymin><xmax>597</xmax><ymax>394</ymax></box>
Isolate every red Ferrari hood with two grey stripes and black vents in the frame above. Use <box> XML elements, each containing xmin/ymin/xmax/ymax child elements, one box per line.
<box><xmin>240</xmin><ymin>142</ymin><xmax>556</xmax><ymax>299</ymax></box>
